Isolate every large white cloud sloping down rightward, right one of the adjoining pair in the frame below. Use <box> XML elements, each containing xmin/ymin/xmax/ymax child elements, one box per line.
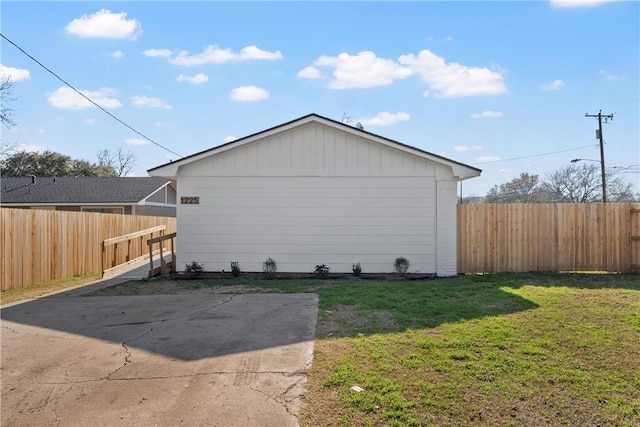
<box><xmin>399</xmin><ymin>50</ymin><xmax>507</xmax><ymax>98</ymax></box>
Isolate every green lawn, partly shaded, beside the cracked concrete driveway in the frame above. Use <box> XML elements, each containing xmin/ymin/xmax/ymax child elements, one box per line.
<box><xmin>86</xmin><ymin>274</ymin><xmax>640</xmax><ymax>427</ymax></box>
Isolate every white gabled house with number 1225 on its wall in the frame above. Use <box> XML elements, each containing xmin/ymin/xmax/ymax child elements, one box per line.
<box><xmin>148</xmin><ymin>114</ymin><xmax>481</xmax><ymax>276</ymax></box>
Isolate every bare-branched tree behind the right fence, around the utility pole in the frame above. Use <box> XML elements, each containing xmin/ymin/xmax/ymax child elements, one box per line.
<box><xmin>544</xmin><ymin>163</ymin><xmax>639</xmax><ymax>203</ymax></box>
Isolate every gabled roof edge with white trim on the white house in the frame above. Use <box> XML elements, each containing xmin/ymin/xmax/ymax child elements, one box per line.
<box><xmin>147</xmin><ymin>113</ymin><xmax>482</xmax><ymax>179</ymax></box>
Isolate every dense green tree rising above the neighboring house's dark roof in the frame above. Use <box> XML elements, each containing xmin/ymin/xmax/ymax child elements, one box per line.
<box><xmin>0</xmin><ymin>151</ymin><xmax>116</xmax><ymax>176</ymax></box>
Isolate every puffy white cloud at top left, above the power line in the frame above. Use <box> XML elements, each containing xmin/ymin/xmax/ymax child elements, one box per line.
<box><xmin>65</xmin><ymin>9</ymin><xmax>142</xmax><ymax>40</ymax></box>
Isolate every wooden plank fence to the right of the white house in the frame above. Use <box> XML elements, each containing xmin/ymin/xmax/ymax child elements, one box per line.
<box><xmin>457</xmin><ymin>203</ymin><xmax>640</xmax><ymax>273</ymax></box>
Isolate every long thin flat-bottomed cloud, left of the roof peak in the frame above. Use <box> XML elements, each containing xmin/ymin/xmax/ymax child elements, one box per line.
<box><xmin>169</xmin><ymin>46</ymin><xmax>282</xmax><ymax>67</ymax></box>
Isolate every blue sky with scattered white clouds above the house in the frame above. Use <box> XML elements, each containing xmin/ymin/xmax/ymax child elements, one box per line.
<box><xmin>0</xmin><ymin>0</ymin><xmax>640</xmax><ymax>195</ymax></box>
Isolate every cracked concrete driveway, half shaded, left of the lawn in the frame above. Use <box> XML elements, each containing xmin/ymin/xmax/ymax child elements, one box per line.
<box><xmin>0</xmin><ymin>282</ymin><xmax>318</xmax><ymax>427</ymax></box>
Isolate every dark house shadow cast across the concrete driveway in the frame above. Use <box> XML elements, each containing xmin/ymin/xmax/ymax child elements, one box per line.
<box><xmin>1</xmin><ymin>294</ymin><xmax>317</xmax><ymax>360</ymax></box>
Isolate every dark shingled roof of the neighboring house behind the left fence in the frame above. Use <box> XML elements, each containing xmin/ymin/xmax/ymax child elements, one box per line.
<box><xmin>0</xmin><ymin>176</ymin><xmax>169</xmax><ymax>205</ymax></box>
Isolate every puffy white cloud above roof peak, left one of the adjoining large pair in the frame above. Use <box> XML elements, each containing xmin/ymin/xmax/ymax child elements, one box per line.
<box><xmin>307</xmin><ymin>51</ymin><xmax>413</xmax><ymax>89</ymax></box>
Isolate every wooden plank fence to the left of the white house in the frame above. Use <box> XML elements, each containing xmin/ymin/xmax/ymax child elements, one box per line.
<box><xmin>0</xmin><ymin>208</ymin><xmax>176</xmax><ymax>291</ymax></box>
